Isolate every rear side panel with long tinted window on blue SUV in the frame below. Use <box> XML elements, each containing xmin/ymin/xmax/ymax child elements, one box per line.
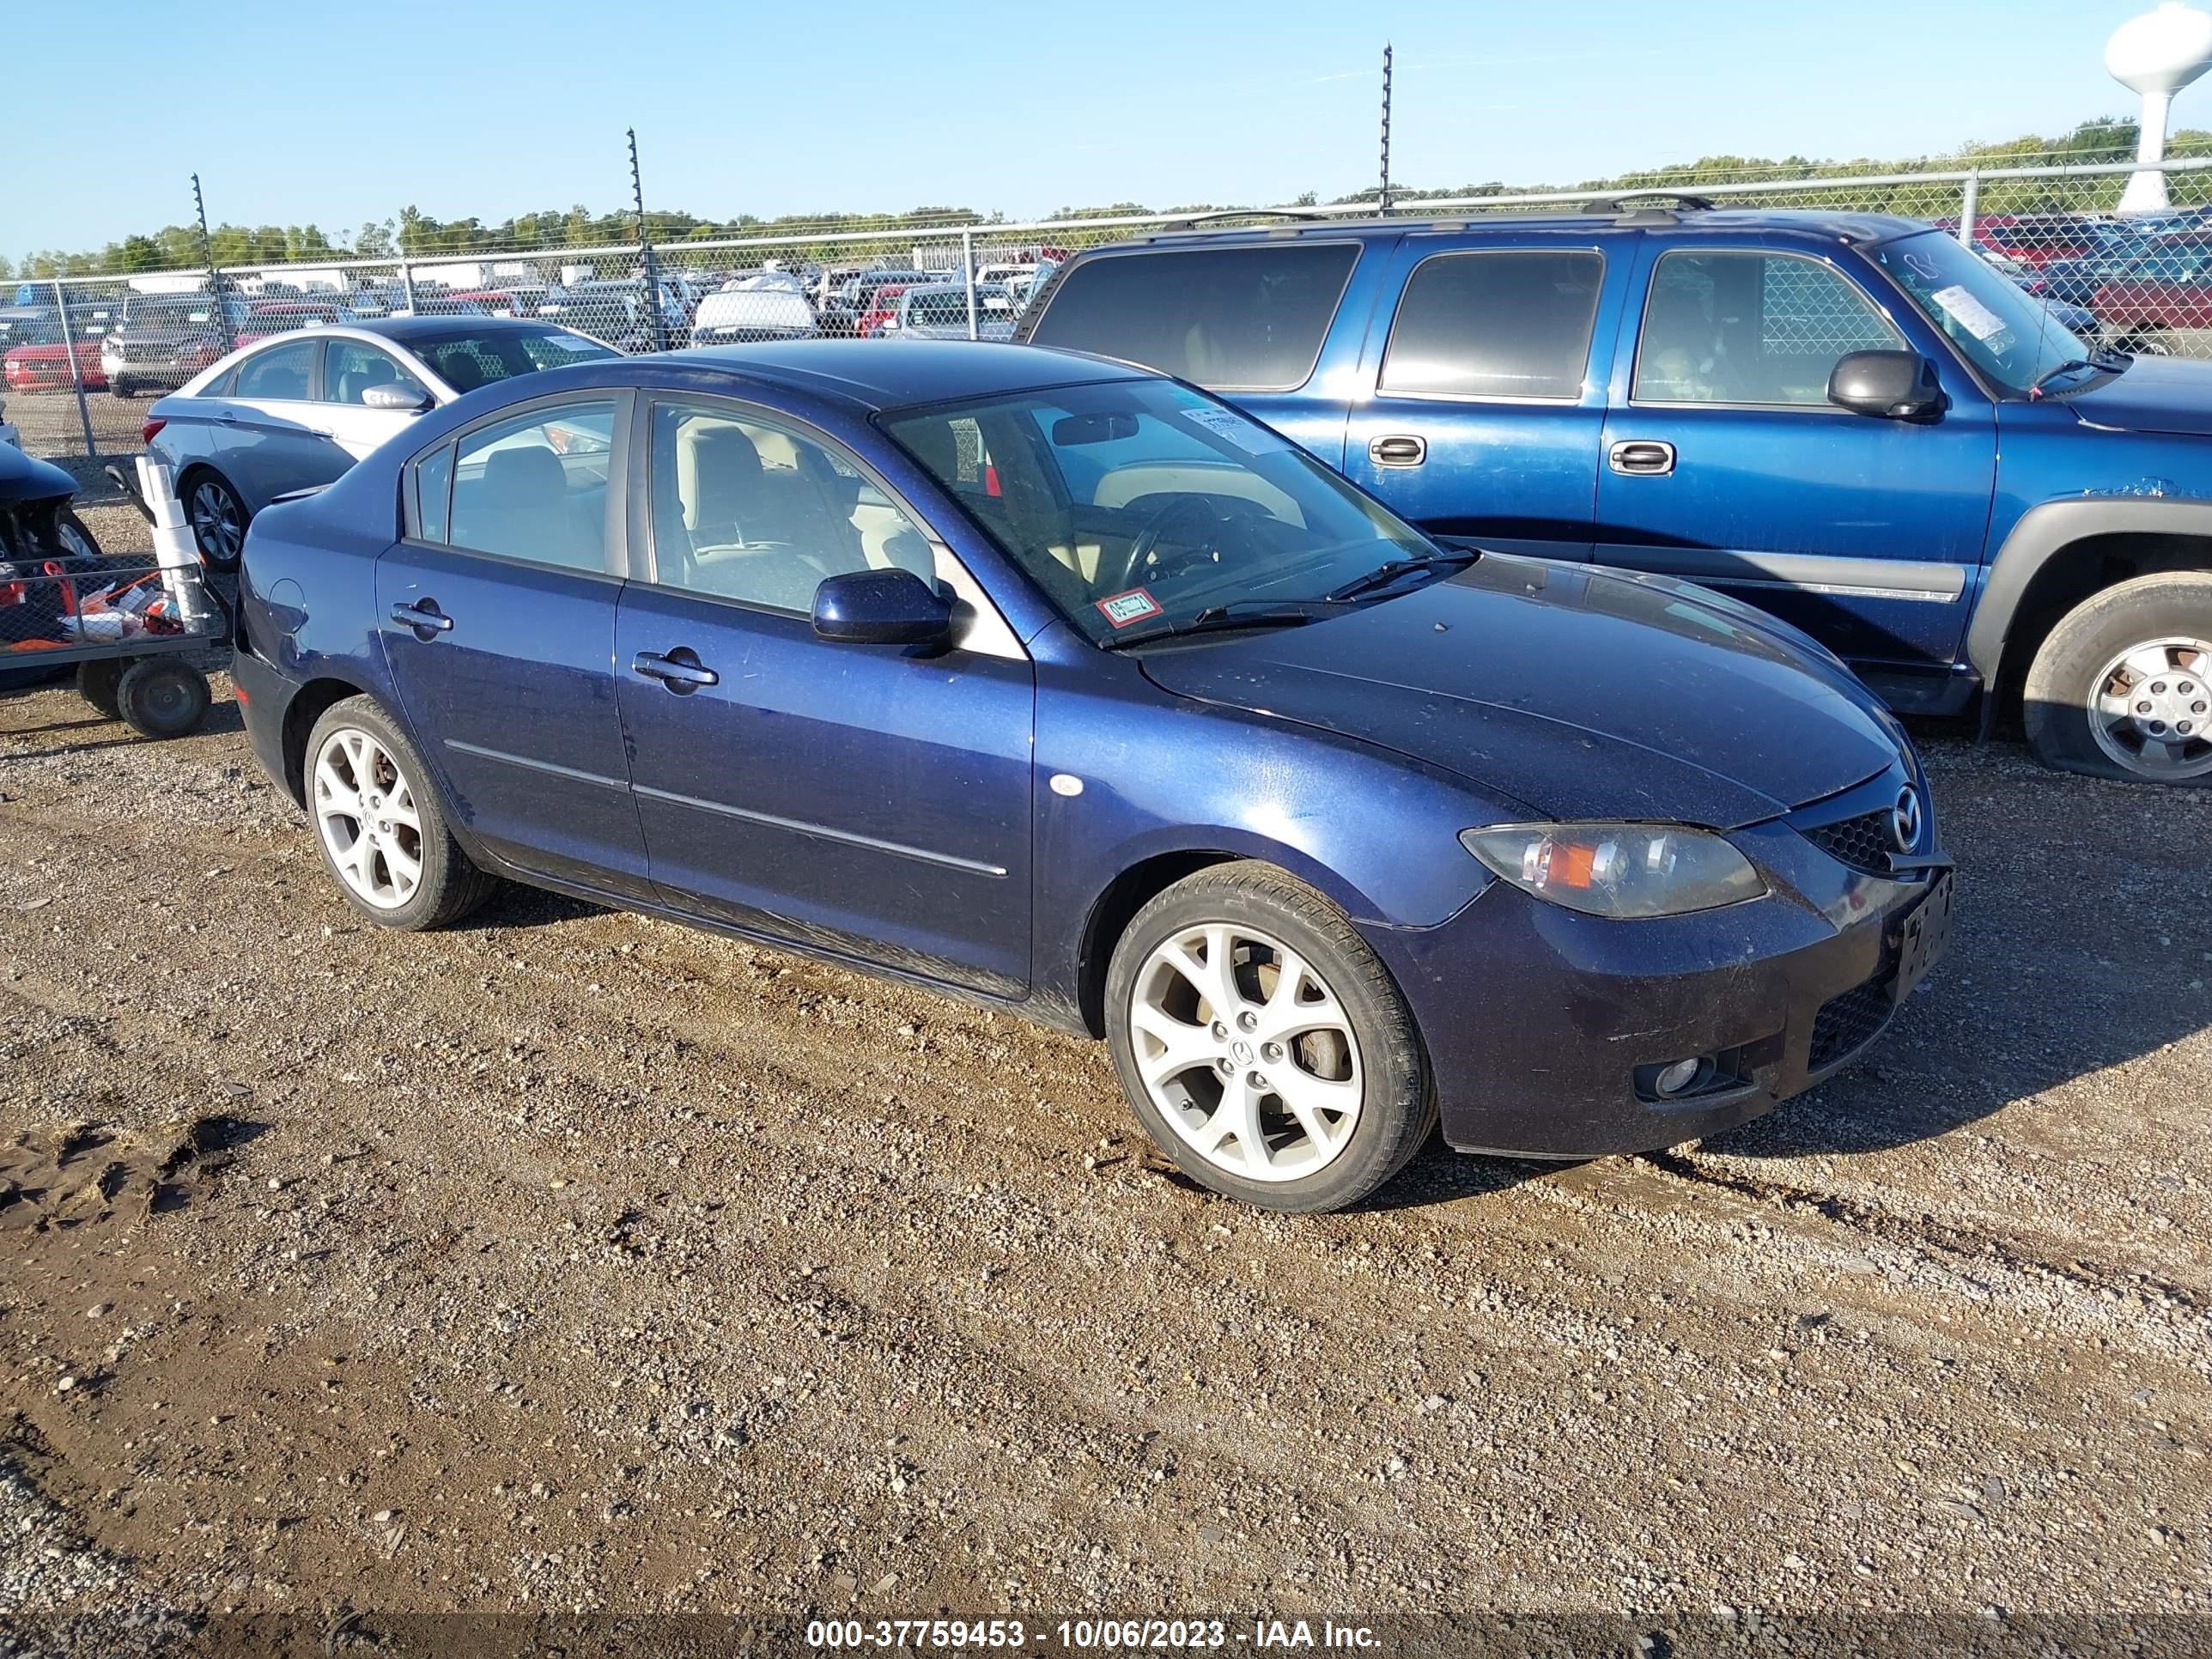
<box><xmin>1029</xmin><ymin>234</ymin><xmax>1391</xmax><ymax>467</ymax></box>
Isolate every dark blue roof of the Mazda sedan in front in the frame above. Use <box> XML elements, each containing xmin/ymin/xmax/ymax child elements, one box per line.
<box><xmin>650</xmin><ymin>341</ymin><xmax>1155</xmax><ymax>410</ymax></box>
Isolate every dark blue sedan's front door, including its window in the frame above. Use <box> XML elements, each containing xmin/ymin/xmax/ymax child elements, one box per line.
<box><xmin>615</xmin><ymin>400</ymin><xmax>1036</xmax><ymax>995</ymax></box>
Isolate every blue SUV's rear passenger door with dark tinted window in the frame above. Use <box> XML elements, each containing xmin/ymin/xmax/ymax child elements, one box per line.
<box><xmin>1343</xmin><ymin>230</ymin><xmax>1641</xmax><ymax>560</ymax></box>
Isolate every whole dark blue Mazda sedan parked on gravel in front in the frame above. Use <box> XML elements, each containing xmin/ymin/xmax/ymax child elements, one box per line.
<box><xmin>234</xmin><ymin>341</ymin><xmax>1951</xmax><ymax>1210</ymax></box>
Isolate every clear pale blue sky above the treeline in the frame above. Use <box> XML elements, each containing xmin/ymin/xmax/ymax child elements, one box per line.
<box><xmin>0</xmin><ymin>0</ymin><xmax>2212</xmax><ymax>254</ymax></box>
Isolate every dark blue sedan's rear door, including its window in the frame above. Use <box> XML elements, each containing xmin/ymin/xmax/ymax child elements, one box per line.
<box><xmin>376</xmin><ymin>396</ymin><xmax>653</xmax><ymax>896</ymax></box>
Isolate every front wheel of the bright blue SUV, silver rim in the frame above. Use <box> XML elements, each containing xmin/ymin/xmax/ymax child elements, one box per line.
<box><xmin>2021</xmin><ymin>571</ymin><xmax>2212</xmax><ymax>783</ymax></box>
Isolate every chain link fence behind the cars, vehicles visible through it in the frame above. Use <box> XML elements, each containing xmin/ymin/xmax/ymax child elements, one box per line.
<box><xmin>13</xmin><ymin>157</ymin><xmax>2212</xmax><ymax>477</ymax></box>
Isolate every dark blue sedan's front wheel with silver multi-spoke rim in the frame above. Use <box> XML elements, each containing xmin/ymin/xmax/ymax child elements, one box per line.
<box><xmin>1106</xmin><ymin>863</ymin><xmax>1436</xmax><ymax>1214</ymax></box>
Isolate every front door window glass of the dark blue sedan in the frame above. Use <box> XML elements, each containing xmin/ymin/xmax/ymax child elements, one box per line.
<box><xmin>653</xmin><ymin>403</ymin><xmax>936</xmax><ymax>615</ymax></box>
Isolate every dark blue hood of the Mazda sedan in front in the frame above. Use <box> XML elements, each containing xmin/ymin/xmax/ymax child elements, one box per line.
<box><xmin>1144</xmin><ymin>553</ymin><xmax>1900</xmax><ymax>830</ymax></box>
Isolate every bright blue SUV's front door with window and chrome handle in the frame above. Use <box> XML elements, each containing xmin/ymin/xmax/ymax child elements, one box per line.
<box><xmin>1597</xmin><ymin>241</ymin><xmax>1997</xmax><ymax>671</ymax></box>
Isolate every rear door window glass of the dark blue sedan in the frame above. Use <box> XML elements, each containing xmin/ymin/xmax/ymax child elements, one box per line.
<box><xmin>444</xmin><ymin>400</ymin><xmax>615</xmax><ymax>571</ymax></box>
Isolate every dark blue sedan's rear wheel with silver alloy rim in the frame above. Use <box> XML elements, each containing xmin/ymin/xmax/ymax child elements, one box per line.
<box><xmin>305</xmin><ymin>696</ymin><xmax>498</xmax><ymax>933</ymax></box>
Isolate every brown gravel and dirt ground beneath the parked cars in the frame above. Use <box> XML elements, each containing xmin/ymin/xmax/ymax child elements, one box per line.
<box><xmin>0</xmin><ymin>514</ymin><xmax>2212</xmax><ymax>1652</ymax></box>
